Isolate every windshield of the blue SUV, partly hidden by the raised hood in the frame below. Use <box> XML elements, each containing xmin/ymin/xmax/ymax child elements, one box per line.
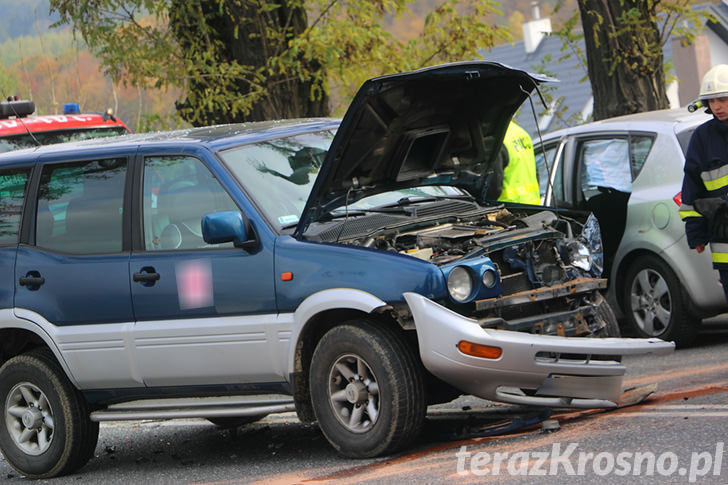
<box><xmin>220</xmin><ymin>131</ymin><xmax>467</xmax><ymax>230</ymax></box>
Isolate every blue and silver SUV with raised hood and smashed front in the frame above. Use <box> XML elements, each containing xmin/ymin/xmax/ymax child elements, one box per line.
<box><xmin>0</xmin><ymin>62</ymin><xmax>673</xmax><ymax>477</ymax></box>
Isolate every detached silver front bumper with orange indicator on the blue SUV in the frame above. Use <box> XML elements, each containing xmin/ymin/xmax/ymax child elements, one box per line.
<box><xmin>404</xmin><ymin>293</ymin><xmax>675</xmax><ymax>408</ymax></box>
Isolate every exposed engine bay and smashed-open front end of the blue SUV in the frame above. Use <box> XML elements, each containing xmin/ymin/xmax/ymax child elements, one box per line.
<box><xmin>306</xmin><ymin>199</ymin><xmax>611</xmax><ymax>335</ymax></box>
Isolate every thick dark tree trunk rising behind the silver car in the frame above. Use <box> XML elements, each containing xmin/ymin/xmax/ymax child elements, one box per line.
<box><xmin>557</xmin><ymin>0</ymin><xmax>700</xmax><ymax>120</ymax></box>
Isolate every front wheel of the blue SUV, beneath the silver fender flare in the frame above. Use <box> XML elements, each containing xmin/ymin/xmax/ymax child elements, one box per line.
<box><xmin>310</xmin><ymin>319</ymin><xmax>426</xmax><ymax>458</ymax></box>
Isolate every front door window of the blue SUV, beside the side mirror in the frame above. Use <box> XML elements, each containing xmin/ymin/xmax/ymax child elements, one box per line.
<box><xmin>143</xmin><ymin>156</ymin><xmax>240</xmax><ymax>251</ymax></box>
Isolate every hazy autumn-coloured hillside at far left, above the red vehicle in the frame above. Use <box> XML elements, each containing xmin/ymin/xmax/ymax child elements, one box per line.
<box><xmin>0</xmin><ymin>0</ymin><xmax>184</xmax><ymax>131</ymax></box>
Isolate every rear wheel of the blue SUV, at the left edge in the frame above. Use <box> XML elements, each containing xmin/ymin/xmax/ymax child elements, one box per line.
<box><xmin>0</xmin><ymin>349</ymin><xmax>99</xmax><ymax>478</ymax></box>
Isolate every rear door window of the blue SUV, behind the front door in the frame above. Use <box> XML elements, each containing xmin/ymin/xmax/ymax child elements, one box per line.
<box><xmin>35</xmin><ymin>159</ymin><xmax>126</xmax><ymax>254</ymax></box>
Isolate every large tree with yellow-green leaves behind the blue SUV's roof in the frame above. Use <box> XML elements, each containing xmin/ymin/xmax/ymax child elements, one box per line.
<box><xmin>51</xmin><ymin>0</ymin><xmax>510</xmax><ymax>125</ymax></box>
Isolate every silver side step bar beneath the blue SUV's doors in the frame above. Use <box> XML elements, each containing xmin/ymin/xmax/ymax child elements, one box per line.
<box><xmin>90</xmin><ymin>395</ymin><xmax>296</xmax><ymax>422</ymax></box>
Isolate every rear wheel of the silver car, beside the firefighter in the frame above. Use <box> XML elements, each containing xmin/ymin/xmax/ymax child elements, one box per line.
<box><xmin>622</xmin><ymin>255</ymin><xmax>700</xmax><ymax>347</ymax></box>
